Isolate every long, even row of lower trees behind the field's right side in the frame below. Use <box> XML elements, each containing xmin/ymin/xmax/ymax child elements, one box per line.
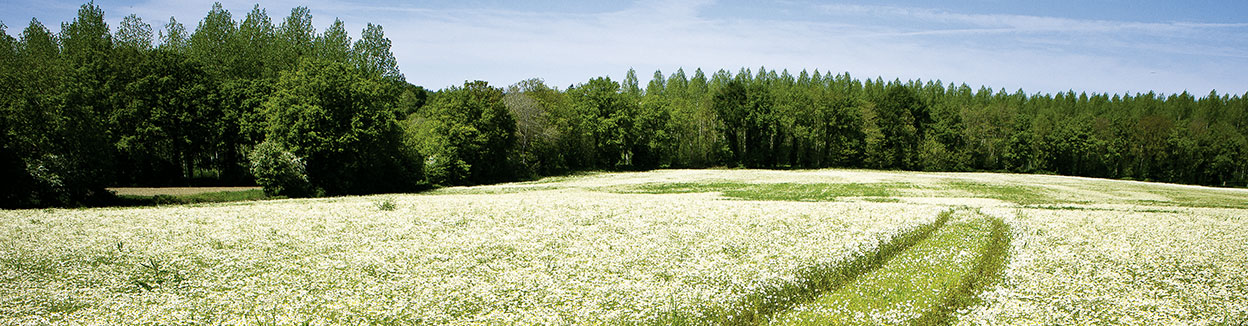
<box><xmin>504</xmin><ymin>67</ymin><xmax>1248</xmax><ymax>186</ymax></box>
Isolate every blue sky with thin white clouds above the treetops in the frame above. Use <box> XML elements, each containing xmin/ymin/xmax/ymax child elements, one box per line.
<box><xmin>0</xmin><ymin>0</ymin><xmax>1248</xmax><ymax>95</ymax></box>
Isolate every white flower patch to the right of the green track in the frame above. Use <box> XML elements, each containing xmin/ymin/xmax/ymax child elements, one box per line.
<box><xmin>958</xmin><ymin>207</ymin><xmax>1248</xmax><ymax>325</ymax></box>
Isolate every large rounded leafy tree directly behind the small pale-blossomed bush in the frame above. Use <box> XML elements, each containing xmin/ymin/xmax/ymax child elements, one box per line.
<box><xmin>263</xmin><ymin>59</ymin><xmax>421</xmax><ymax>195</ymax></box>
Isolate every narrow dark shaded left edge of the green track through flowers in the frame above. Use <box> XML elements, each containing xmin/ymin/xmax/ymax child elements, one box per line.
<box><xmin>678</xmin><ymin>210</ymin><xmax>953</xmax><ymax>325</ymax></box>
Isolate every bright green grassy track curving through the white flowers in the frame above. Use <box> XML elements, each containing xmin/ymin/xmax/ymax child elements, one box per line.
<box><xmin>771</xmin><ymin>214</ymin><xmax>1008</xmax><ymax>325</ymax></box>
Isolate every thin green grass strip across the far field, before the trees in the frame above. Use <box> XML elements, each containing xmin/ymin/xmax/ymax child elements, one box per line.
<box><xmin>608</xmin><ymin>182</ymin><xmax>899</xmax><ymax>201</ymax></box>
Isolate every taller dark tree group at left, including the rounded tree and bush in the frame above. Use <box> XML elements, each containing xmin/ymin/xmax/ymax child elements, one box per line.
<box><xmin>0</xmin><ymin>2</ymin><xmax>428</xmax><ymax>207</ymax></box>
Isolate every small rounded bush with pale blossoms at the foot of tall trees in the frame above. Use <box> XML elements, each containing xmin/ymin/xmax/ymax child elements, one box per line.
<box><xmin>250</xmin><ymin>141</ymin><xmax>311</xmax><ymax>197</ymax></box>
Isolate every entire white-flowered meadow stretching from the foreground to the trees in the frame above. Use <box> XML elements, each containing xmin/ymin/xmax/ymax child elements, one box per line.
<box><xmin>0</xmin><ymin>170</ymin><xmax>1248</xmax><ymax>325</ymax></box>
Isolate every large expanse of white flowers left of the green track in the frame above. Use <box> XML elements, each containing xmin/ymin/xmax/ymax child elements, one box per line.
<box><xmin>0</xmin><ymin>189</ymin><xmax>945</xmax><ymax>325</ymax></box>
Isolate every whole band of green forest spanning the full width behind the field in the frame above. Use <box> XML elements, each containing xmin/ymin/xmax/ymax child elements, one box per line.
<box><xmin>0</xmin><ymin>4</ymin><xmax>1248</xmax><ymax>207</ymax></box>
